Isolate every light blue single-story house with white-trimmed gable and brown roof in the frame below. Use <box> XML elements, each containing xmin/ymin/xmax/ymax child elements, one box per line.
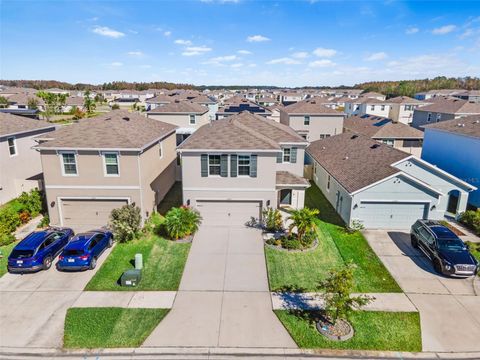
<box><xmin>307</xmin><ymin>132</ymin><xmax>476</xmax><ymax>229</ymax></box>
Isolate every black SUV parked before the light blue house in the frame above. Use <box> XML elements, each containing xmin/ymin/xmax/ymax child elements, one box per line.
<box><xmin>410</xmin><ymin>220</ymin><xmax>479</xmax><ymax>276</ymax></box>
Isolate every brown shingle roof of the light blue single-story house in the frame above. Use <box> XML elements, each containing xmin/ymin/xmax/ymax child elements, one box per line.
<box><xmin>307</xmin><ymin>132</ymin><xmax>410</xmax><ymax>193</ymax></box>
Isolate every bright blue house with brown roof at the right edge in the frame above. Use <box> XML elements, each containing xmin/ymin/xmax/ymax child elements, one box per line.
<box><xmin>422</xmin><ymin>115</ymin><xmax>480</xmax><ymax>214</ymax></box>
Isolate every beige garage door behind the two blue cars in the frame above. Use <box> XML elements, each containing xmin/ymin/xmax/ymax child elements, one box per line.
<box><xmin>61</xmin><ymin>199</ymin><xmax>127</xmax><ymax>232</ymax></box>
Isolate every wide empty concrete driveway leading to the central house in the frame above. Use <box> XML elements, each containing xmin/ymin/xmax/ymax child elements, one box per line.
<box><xmin>144</xmin><ymin>225</ymin><xmax>296</xmax><ymax>348</ymax></box>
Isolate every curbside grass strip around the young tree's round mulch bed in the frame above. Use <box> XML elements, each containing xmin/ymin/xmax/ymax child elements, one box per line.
<box><xmin>275</xmin><ymin>310</ymin><xmax>422</xmax><ymax>352</ymax></box>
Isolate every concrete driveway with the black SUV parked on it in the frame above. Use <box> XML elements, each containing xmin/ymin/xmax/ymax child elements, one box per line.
<box><xmin>364</xmin><ymin>230</ymin><xmax>480</xmax><ymax>352</ymax></box>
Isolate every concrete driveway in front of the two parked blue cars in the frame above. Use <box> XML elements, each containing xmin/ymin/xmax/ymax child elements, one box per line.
<box><xmin>0</xmin><ymin>249</ymin><xmax>111</xmax><ymax>348</ymax></box>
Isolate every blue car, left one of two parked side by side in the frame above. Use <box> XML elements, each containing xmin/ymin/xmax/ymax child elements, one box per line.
<box><xmin>7</xmin><ymin>228</ymin><xmax>74</xmax><ymax>273</ymax></box>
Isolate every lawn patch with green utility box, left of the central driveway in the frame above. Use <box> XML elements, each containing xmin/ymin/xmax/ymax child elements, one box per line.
<box><xmin>85</xmin><ymin>234</ymin><xmax>191</xmax><ymax>291</ymax></box>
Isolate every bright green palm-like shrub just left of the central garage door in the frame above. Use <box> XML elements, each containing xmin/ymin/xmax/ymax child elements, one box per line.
<box><xmin>163</xmin><ymin>206</ymin><xmax>202</xmax><ymax>240</ymax></box>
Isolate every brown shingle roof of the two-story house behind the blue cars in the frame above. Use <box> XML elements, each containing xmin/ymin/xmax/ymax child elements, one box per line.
<box><xmin>34</xmin><ymin>110</ymin><xmax>176</xmax><ymax>150</ymax></box>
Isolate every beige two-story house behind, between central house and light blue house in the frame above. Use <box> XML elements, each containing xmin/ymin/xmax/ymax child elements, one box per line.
<box><xmin>280</xmin><ymin>99</ymin><xmax>345</xmax><ymax>142</ymax></box>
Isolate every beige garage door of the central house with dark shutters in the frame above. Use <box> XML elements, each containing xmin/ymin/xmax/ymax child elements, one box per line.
<box><xmin>197</xmin><ymin>200</ymin><xmax>261</xmax><ymax>226</ymax></box>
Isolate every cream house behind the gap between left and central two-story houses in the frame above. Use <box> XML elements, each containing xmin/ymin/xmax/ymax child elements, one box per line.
<box><xmin>147</xmin><ymin>99</ymin><xmax>210</xmax><ymax>145</ymax></box>
